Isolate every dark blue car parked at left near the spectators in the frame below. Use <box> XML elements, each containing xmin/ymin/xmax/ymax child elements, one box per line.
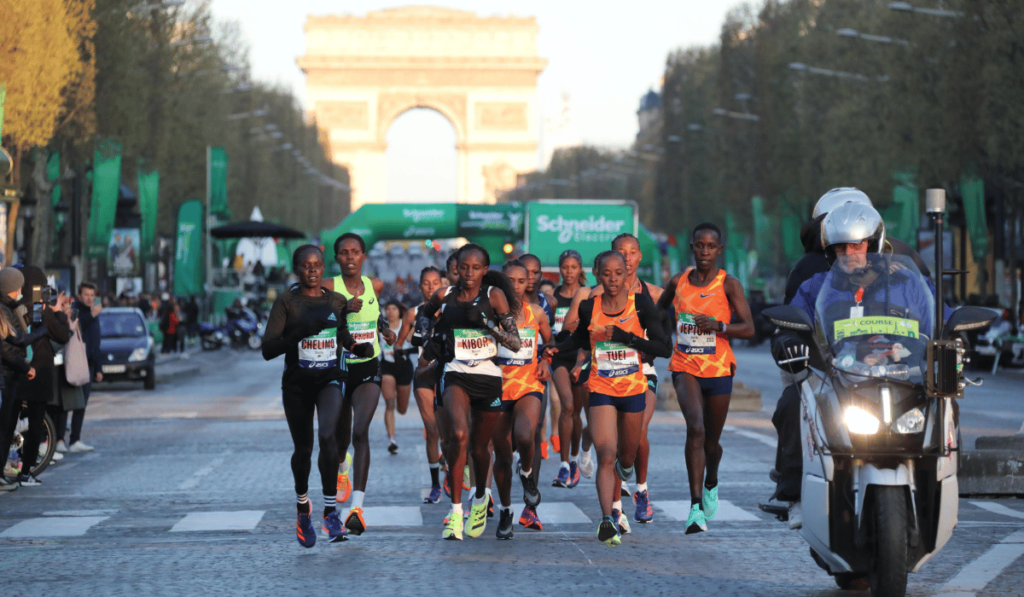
<box><xmin>99</xmin><ymin>307</ymin><xmax>157</xmax><ymax>390</ymax></box>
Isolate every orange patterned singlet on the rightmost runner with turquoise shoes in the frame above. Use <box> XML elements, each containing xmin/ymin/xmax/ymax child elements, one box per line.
<box><xmin>669</xmin><ymin>267</ymin><xmax>736</xmax><ymax>378</ymax></box>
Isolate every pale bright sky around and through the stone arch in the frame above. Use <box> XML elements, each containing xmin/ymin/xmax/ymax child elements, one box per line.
<box><xmin>203</xmin><ymin>0</ymin><xmax>738</xmax><ymax>201</ymax></box>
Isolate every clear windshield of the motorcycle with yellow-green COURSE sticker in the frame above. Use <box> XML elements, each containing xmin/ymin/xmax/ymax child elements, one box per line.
<box><xmin>815</xmin><ymin>254</ymin><xmax>935</xmax><ymax>383</ymax></box>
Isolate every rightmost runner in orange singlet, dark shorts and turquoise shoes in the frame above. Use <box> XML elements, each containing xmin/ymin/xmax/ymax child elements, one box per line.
<box><xmin>657</xmin><ymin>223</ymin><xmax>754</xmax><ymax>535</ymax></box>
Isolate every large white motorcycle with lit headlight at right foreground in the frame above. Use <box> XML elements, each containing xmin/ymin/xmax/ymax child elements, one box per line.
<box><xmin>762</xmin><ymin>253</ymin><xmax>994</xmax><ymax>597</ymax></box>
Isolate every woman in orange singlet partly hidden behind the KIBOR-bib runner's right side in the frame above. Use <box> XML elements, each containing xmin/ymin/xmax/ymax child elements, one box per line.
<box><xmin>494</xmin><ymin>260</ymin><xmax>551</xmax><ymax>539</ymax></box>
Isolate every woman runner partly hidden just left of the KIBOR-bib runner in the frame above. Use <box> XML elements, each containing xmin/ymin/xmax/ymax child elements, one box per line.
<box><xmin>395</xmin><ymin>266</ymin><xmax>441</xmax><ymax>504</ymax></box>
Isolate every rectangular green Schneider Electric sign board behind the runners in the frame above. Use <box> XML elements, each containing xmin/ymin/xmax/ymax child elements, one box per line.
<box><xmin>525</xmin><ymin>201</ymin><xmax>637</xmax><ymax>267</ymax></box>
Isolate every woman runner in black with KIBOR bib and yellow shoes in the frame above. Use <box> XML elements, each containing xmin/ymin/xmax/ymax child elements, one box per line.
<box><xmin>423</xmin><ymin>244</ymin><xmax>520</xmax><ymax>541</ymax></box>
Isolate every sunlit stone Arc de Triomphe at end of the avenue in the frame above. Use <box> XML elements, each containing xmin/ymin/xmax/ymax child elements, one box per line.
<box><xmin>298</xmin><ymin>7</ymin><xmax>547</xmax><ymax>212</ymax></box>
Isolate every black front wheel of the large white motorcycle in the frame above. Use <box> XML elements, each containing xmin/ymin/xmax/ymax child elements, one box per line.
<box><xmin>868</xmin><ymin>486</ymin><xmax>907</xmax><ymax>597</ymax></box>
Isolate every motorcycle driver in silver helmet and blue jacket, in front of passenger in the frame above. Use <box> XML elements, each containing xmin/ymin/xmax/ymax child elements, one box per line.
<box><xmin>772</xmin><ymin>200</ymin><xmax>932</xmax><ymax>528</ymax></box>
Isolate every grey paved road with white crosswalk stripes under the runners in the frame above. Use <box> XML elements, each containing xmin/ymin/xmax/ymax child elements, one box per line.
<box><xmin>0</xmin><ymin>349</ymin><xmax>1024</xmax><ymax>597</ymax></box>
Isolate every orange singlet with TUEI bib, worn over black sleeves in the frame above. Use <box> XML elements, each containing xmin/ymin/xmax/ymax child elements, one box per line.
<box><xmin>588</xmin><ymin>294</ymin><xmax>647</xmax><ymax>397</ymax></box>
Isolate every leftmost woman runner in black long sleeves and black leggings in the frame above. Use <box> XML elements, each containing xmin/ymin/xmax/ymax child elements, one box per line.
<box><xmin>263</xmin><ymin>245</ymin><xmax>373</xmax><ymax>547</ymax></box>
